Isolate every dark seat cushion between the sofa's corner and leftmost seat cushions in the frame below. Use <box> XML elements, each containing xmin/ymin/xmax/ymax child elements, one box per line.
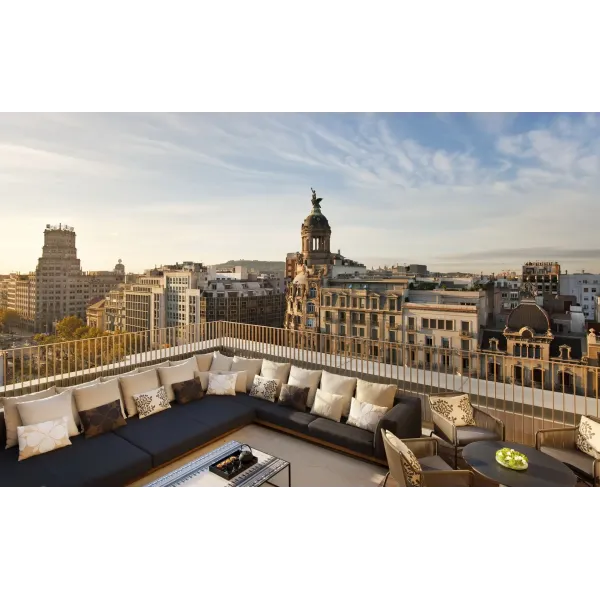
<box><xmin>112</xmin><ymin>400</ymin><xmax>213</xmax><ymax>467</ymax></box>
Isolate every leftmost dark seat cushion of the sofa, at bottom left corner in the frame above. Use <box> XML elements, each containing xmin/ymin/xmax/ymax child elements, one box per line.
<box><xmin>0</xmin><ymin>427</ymin><xmax>152</xmax><ymax>488</ymax></box>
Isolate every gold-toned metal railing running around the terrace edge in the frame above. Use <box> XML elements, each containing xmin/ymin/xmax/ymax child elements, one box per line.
<box><xmin>0</xmin><ymin>321</ymin><xmax>600</xmax><ymax>444</ymax></box>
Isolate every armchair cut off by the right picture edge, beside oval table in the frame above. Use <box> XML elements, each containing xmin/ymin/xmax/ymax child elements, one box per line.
<box><xmin>535</xmin><ymin>416</ymin><xmax>600</xmax><ymax>487</ymax></box>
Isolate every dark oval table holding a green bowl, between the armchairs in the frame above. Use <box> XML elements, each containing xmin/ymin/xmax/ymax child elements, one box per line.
<box><xmin>462</xmin><ymin>442</ymin><xmax>577</xmax><ymax>488</ymax></box>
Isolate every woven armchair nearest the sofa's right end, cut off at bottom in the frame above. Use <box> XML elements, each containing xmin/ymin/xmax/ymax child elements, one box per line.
<box><xmin>382</xmin><ymin>431</ymin><xmax>473</xmax><ymax>488</ymax></box>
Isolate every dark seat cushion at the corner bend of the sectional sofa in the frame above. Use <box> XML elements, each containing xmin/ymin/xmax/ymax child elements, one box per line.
<box><xmin>177</xmin><ymin>396</ymin><xmax>255</xmax><ymax>438</ymax></box>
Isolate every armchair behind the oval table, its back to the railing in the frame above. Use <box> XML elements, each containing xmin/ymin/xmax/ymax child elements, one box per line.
<box><xmin>430</xmin><ymin>393</ymin><xmax>505</xmax><ymax>468</ymax></box>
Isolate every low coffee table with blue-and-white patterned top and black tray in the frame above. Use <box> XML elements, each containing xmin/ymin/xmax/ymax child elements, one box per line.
<box><xmin>144</xmin><ymin>441</ymin><xmax>292</xmax><ymax>488</ymax></box>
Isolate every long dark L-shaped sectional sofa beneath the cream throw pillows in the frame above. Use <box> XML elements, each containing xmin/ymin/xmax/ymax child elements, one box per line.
<box><xmin>0</xmin><ymin>353</ymin><xmax>421</xmax><ymax>487</ymax></box>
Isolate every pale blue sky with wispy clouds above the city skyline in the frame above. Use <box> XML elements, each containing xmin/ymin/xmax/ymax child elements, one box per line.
<box><xmin>0</xmin><ymin>113</ymin><xmax>600</xmax><ymax>273</ymax></box>
